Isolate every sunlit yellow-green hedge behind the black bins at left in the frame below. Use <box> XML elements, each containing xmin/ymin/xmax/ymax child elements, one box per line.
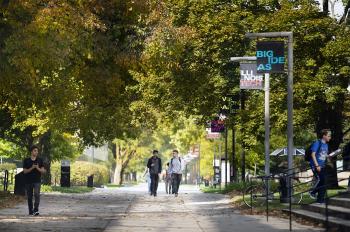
<box><xmin>51</xmin><ymin>161</ymin><xmax>109</xmax><ymax>186</ymax></box>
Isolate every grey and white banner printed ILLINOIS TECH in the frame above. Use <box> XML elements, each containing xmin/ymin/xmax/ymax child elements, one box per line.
<box><xmin>239</xmin><ymin>63</ymin><xmax>264</xmax><ymax>89</ymax></box>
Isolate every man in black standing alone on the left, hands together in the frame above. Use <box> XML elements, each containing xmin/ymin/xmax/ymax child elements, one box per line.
<box><xmin>23</xmin><ymin>145</ymin><xmax>46</xmax><ymax>216</ymax></box>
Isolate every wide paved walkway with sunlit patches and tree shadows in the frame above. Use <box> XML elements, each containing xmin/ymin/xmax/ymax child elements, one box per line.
<box><xmin>0</xmin><ymin>183</ymin><xmax>320</xmax><ymax>232</ymax></box>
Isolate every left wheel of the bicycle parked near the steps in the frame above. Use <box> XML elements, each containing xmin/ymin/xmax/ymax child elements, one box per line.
<box><xmin>243</xmin><ymin>183</ymin><xmax>266</xmax><ymax>208</ymax></box>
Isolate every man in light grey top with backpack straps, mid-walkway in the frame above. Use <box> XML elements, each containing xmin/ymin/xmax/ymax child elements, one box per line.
<box><xmin>170</xmin><ymin>150</ymin><xmax>184</xmax><ymax>197</ymax></box>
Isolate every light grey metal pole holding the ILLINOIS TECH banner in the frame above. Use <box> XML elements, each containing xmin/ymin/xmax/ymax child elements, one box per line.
<box><xmin>265</xmin><ymin>73</ymin><xmax>270</xmax><ymax>197</ymax></box>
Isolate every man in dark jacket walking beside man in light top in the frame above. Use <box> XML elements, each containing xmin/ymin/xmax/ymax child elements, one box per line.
<box><xmin>147</xmin><ymin>150</ymin><xmax>162</xmax><ymax>196</ymax></box>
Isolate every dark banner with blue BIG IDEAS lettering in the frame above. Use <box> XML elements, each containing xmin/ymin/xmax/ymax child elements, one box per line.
<box><xmin>256</xmin><ymin>41</ymin><xmax>285</xmax><ymax>73</ymax></box>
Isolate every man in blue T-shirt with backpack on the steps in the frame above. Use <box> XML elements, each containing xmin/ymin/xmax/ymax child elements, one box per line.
<box><xmin>305</xmin><ymin>129</ymin><xmax>331</xmax><ymax>204</ymax></box>
